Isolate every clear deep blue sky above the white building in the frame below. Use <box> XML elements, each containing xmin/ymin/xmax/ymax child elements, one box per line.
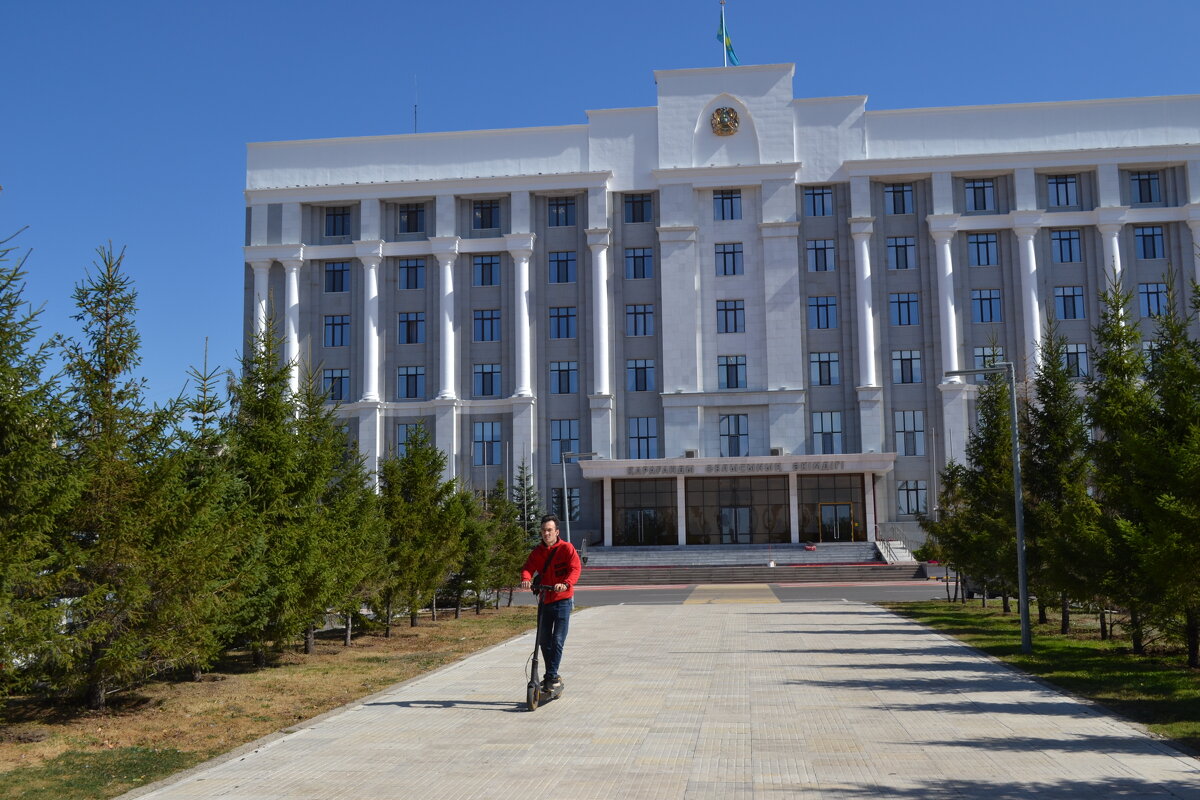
<box><xmin>0</xmin><ymin>0</ymin><xmax>1200</xmax><ymax>401</ymax></box>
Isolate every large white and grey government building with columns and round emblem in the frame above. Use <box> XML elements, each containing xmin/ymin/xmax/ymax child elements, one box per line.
<box><xmin>238</xmin><ymin>64</ymin><xmax>1200</xmax><ymax>546</ymax></box>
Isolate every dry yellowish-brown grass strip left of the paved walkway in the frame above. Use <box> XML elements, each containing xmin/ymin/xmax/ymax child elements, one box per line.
<box><xmin>0</xmin><ymin>607</ymin><xmax>536</xmax><ymax>800</ymax></box>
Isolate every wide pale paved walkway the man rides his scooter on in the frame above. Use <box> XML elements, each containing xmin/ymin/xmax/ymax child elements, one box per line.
<box><xmin>128</xmin><ymin>597</ymin><xmax>1200</xmax><ymax>800</ymax></box>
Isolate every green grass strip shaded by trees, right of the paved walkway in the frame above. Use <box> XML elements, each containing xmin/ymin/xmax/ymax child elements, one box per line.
<box><xmin>883</xmin><ymin>601</ymin><xmax>1200</xmax><ymax>752</ymax></box>
